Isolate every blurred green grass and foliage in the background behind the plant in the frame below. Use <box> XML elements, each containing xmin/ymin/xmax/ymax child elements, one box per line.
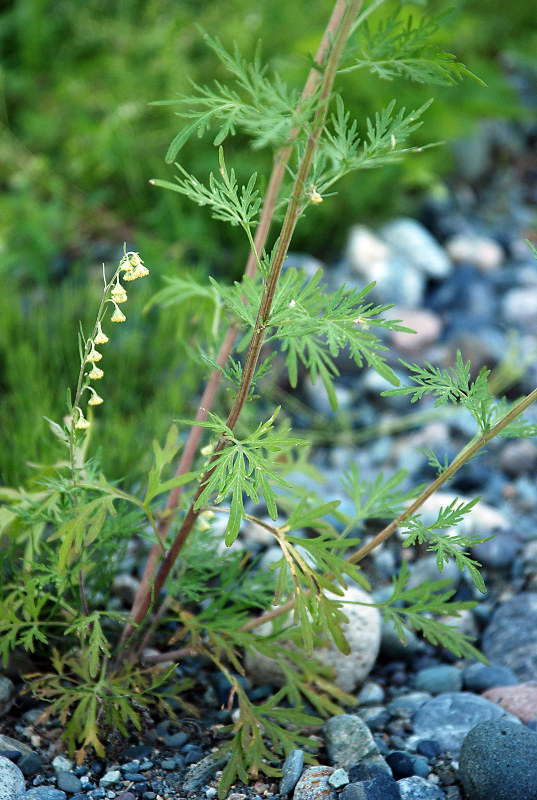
<box><xmin>0</xmin><ymin>0</ymin><xmax>537</xmax><ymax>484</ymax></box>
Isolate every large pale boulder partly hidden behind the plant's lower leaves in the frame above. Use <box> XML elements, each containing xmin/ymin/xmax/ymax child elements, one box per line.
<box><xmin>245</xmin><ymin>586</ymin><xmax>381</xmax><ymax>692</ymax></box>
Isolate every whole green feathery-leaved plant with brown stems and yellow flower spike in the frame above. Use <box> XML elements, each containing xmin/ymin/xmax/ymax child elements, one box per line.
<box><xmin>0</xmin><ymin>0</ymin><xmax>537</xmax><ymax>797</ymax></box>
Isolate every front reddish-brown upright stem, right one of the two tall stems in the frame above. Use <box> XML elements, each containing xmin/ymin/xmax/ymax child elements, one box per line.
<box><xmin>122</xmin><ymin>0</ymin><xmax>362</xmax><ymax>641</ymax></box>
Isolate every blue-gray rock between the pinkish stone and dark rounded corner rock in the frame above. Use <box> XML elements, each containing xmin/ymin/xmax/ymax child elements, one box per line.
<box><xmin>409</xmin><ymin>692</ymin><xmax>520</xmax><ymax>758</ymax></box>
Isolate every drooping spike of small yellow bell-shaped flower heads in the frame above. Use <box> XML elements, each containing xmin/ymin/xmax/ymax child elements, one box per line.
<box><xmin>74</xmin><ymin>252</ymin><xmax>149</xmax><ymax>430</ymax></box>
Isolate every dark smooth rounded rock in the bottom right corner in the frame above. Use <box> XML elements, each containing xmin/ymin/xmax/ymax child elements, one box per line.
<box><xmin>459</xmin><ymin>720</ymin><xmax>537</xmax><ymax>800</ymax></box>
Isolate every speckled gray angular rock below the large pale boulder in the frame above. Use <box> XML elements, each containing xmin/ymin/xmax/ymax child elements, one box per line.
<box><xmin>323</xmin><ymin>714</ymin><xmax>390</xmax><ymax>772</ymax></box>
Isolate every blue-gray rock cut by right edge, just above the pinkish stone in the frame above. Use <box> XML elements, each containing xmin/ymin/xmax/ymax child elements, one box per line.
<box><xmin>482</xmin><ymin>592</ymin><xmax>537</xmax><ymax>681</ymax></box>
